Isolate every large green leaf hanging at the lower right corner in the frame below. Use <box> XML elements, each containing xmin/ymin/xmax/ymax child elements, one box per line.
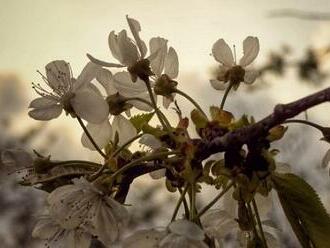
<box><xmin>272</xmin><ymin>173</ymin><xmax>330</xmax><ymax>248</ymax></box>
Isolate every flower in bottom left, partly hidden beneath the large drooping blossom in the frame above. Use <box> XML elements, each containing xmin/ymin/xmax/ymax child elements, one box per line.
<box><xmin>32</xmin><ymin>209</ymin><xmax>92</xmax><ymax>248</ymax></box>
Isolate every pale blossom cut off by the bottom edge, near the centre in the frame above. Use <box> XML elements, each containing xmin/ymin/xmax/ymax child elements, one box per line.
<box><xmin>123</xmin><ymin>220</ymin><xmax>208</xmax><ymax>248</ymax></box>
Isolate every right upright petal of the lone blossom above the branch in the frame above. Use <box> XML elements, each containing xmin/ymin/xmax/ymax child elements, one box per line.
<box><xmin>239</xmin><ymin>36</ymin><xmax>260</xmax><ymax>67</ymax></box>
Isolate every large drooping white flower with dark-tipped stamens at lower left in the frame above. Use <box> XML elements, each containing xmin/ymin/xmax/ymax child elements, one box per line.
<box><xmin>47</xmin><ymin>177</ymin><xmax>128</xmax><ymax>246</ymax></box>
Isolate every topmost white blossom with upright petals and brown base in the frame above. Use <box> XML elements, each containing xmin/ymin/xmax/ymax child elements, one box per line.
<box><xmin>87</xmin><ymin>16</ymin><xmax>156</xmax><ymax>82</ymax></box>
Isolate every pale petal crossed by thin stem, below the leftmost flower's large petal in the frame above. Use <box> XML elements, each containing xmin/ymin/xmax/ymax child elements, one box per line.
<box><xmin>81</xmin><ymin>119</ymin><xmax>112</xmax><ymax>151</ymax></box>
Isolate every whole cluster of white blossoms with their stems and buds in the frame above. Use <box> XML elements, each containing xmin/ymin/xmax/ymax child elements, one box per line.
<box><xmin>6</xmin><ymin>13</ymin><xmax>328</xmax><ymax>248</ymax></box>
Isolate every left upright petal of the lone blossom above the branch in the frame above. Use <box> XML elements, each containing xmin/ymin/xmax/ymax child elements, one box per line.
<box><xmin>212</xmin><ymin>39</ymin><xmax>235</xmax><ymax>67</ymax></box>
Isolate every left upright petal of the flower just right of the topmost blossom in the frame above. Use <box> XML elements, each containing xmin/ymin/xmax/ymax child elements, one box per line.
<box><xmin>149</xmin><ymin>37</ymin><xmax>167</xmax><ymax>77</ymax></box>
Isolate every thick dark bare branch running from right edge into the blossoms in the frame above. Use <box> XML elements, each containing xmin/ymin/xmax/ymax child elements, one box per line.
<box><xmin>198</xmin><ymin>87</ymin><xmax>330</xmax><ymax>160</ymax></box>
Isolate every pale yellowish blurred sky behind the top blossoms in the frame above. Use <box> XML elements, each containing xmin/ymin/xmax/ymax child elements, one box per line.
<box><xmin>0</xmin><ymin>0</ymin><xmax>330</xmax><ymax>158</ymax></box>
